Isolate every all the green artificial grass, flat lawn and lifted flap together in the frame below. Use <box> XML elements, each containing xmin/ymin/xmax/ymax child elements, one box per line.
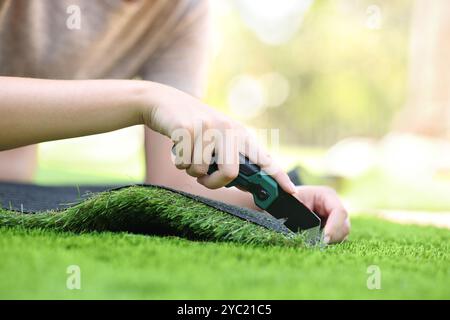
<box><xmin>0</xmin><ymin>188</ymin><xmax>450</xmax><ymax>299</ymax></box>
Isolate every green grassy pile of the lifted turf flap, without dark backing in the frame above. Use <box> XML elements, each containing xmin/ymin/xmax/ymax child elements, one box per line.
<box><xmin>0</xmin><ymin>186</ymin><xmax>305</xmax><ymax>246</ymax></box>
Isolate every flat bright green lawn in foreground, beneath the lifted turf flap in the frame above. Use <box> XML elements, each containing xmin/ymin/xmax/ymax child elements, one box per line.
<box><xmin>0</xmin><ymin>217</ymin><xmax>450</xmax><ymax>299</ymax></box>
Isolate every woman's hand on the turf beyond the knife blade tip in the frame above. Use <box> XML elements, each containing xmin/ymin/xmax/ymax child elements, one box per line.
<box><xmin>294</xmin><ymin>186</ymin><xmax>350</xmax><ymax>243</ymax></box>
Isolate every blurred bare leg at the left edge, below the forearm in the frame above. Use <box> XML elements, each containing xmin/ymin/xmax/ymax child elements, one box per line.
<box><xmin>0</xmin><ymin>145</ymin><xmax>37</xmax><ymax>182</ymax></box>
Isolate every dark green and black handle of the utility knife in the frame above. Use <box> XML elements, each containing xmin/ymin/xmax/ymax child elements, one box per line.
<box><xmin>208</xmin><ymin>154</ymin><xmax>278</xmax><ymax>210</ymax></box>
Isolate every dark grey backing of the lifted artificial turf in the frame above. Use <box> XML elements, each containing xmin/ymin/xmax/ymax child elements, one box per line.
<box><xmin>0</xmin><ymin>183</ymin><xmax>290</xmax><ymax>233</ymax></box>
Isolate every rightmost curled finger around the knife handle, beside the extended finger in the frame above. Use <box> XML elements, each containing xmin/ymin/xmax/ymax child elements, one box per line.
<box><xmin>197</xmin><ymin>134</ymin><xmax>239</xmax><ymax>189</ymax></box>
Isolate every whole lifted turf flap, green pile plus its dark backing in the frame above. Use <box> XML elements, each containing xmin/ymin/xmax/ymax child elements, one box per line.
<box><xmin>0</xmin><ymin>184</ymin><xmax>303</xmax><ymax>245</ymax></box>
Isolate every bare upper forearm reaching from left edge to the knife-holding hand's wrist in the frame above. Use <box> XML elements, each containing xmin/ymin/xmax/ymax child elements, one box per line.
<box><xmin>0</xmin><ymin>77</ymin><xmax>151</xmax><ymax>150</ymax></box>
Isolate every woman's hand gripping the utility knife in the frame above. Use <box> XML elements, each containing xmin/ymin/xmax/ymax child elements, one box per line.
<box><xmin>142</xmin><ymin>83</ymin><xmax>296</xmax><ymax>194</ymax></box>
